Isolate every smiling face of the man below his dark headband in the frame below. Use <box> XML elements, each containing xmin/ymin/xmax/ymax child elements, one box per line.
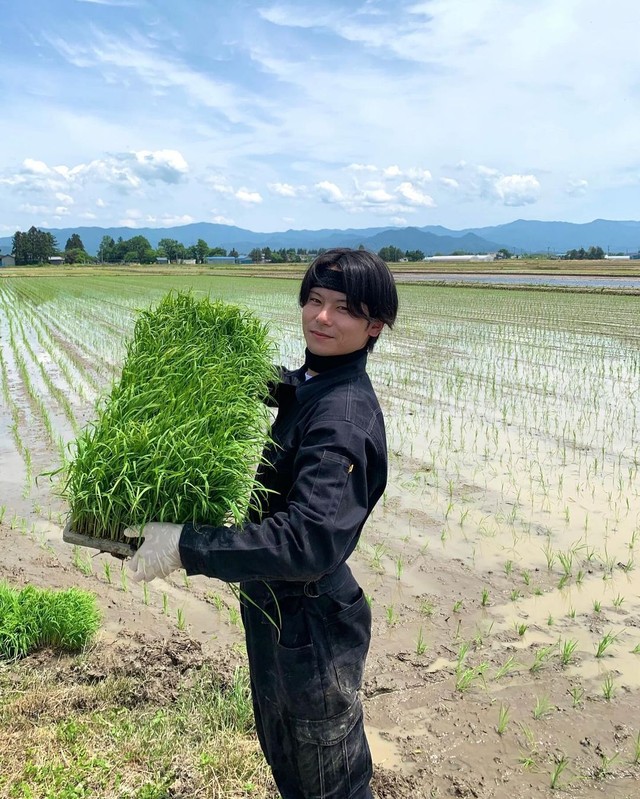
<box><xmin>302</xmin><ymin>287</ymin><xmax>383</xmax><ymax>355</ymax></box>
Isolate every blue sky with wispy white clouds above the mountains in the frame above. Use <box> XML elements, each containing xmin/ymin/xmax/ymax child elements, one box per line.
<box><xmin>0</xmin><ymin>0</ymin><xmax>640</xmax><ymax>235</ymax></box>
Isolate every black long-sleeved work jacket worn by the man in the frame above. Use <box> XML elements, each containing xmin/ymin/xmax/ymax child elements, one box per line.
<box><xmin>180</xmin><ymin>354</ymin><xmax>387</xmax><ymax>583</ymax></box>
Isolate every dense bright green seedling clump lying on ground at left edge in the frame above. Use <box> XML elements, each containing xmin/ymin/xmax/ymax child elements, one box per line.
<box><xmin>0</xmin><ymin>583</ymin><xmax>100</xmax><ymax>660</ymax></box>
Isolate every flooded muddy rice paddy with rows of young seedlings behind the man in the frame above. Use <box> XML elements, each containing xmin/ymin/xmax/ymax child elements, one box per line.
<box><xmin>0</xmin><ymin>270</ymin><xmax>640</xmax><ymax>799</ymax></box>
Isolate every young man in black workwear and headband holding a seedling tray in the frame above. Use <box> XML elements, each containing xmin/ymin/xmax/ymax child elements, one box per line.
<box><xmin>130</xmin><ymin>249</ymin><xmax>398</xmax><ymax>799</ymax></box>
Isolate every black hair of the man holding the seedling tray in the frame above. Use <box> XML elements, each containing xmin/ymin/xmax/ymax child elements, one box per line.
<box><xmin>299</xmin><ymin>247</ymin><xmax>398</xmax><ymax>351</ymax></box>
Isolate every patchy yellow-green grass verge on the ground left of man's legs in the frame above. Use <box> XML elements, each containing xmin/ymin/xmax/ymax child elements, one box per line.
<box><xmin>0</xmin><ymin>665</ymin><xmax>274</xmax><ymax>799</ymax></box>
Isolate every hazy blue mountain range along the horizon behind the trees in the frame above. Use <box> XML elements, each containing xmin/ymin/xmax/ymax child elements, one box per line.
<box><xmin>0</xmin><ymin>219</ymin><xmax>640</xmax><ymax>255</ymax></box>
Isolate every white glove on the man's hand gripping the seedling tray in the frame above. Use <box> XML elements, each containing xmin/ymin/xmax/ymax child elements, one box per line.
<box><xmin>123</xmin><ymin>522</ymin><xmax>182</xmax><ymax>583</ymax></box>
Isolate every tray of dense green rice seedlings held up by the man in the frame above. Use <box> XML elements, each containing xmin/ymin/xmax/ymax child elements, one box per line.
<box><xmin>61</xmin><ymin>292</ymin><xmax>275</xmax><ymax>556</ymax></box>
